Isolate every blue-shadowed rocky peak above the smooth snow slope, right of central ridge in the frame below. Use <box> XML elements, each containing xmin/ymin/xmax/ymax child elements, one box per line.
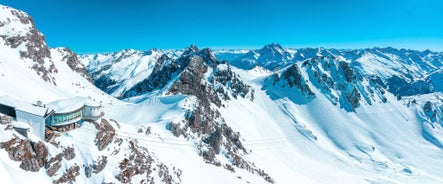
<box><xmin>264</xmin><ymin>56</ymin><xmax>386</xmax><ymax>111</ymax></box>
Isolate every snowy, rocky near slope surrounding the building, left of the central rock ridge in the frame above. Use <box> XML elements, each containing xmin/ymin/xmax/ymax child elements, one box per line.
<box><xmin>0</xmin><ymin>5</ymin><xmax>270</xmax><ymax>183</ymax></box>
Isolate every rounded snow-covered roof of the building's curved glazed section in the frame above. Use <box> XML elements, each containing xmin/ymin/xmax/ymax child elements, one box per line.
<box><xmin>47</xmin><ymin>96</ymin><xmax>100</xmax><ymax>113</ymax></box>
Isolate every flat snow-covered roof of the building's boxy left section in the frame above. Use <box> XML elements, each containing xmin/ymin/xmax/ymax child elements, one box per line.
<box><xmin>0</xmin><ymin>96</ymin><xmax>48</xmax><ymax>117</ymax></box>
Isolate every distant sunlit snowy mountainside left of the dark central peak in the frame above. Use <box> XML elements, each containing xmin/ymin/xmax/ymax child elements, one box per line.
<box><xmin>80</xmin><ymin>49</ymin><xmax>183</xmax><ymax>97</ymax></box>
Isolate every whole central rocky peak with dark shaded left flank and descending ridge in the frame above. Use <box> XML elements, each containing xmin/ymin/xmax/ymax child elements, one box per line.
<box><xmin>123</xmin><ymin>46</ymin><xmax>272</xmax><ymax>182</ymax></box>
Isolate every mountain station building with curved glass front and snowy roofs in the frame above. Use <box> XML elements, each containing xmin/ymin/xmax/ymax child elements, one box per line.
<box><xmin>0</xmin><ymin>97</ymin><xmax>104</xmax><ymax>140</ymax></box>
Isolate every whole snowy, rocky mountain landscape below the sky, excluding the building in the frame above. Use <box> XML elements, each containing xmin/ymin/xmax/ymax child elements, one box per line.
<box><xmin>0</xmin><ymin>3</ymin><xmax>443</xmax><ymax>183</ymax></box>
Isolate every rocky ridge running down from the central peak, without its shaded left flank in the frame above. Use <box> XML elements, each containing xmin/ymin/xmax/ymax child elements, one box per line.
<box><xmin>168</xmin><ymin>51</ymin><xmax>273</xmax><ymax>183</ymax></box>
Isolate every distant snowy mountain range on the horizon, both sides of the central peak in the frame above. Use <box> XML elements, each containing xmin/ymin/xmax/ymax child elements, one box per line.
<box><xmin>81</xmin><ymin>43</ymin><xmax>443</xmax><ymax>97</ymax></box>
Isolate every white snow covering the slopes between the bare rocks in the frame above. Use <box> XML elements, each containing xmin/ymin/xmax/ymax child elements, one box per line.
<box><xmin>0</xmin><ymin>3</ymin><xmax>443</xmax><ymax>184</ymax></box>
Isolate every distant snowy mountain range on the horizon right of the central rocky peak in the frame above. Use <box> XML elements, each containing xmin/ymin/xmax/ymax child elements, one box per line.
<box><xmin>229</xmin><ymin>44</ymin><xmax>443</xmax><ymax>86</ymax></box>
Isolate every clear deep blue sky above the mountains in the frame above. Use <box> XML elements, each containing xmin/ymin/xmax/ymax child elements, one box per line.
<box><xmin>0</xmin><ymin>0</ymin><xmax>443</xmax><ymax>53</ymax></box>
